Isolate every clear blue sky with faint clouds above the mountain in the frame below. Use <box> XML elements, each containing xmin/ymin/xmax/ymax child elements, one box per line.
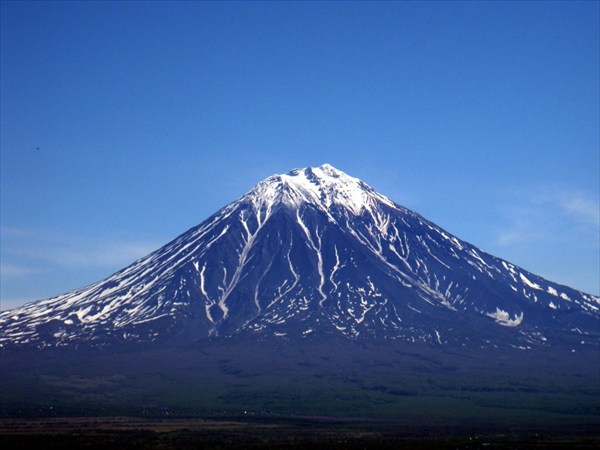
<box><xmin>0</xmin><ymin>1</ymin><xmax>600</xmax><ymax>309</ymax></box>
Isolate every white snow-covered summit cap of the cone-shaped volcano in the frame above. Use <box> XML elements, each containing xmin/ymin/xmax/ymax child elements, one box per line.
<box><xmin>243</xmin><ymin>164</ymin><xmax>396</xmax><ymax>215</ymax></box>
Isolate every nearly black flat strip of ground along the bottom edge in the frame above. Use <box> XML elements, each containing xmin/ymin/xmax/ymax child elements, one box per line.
<box><xmin>0</xmin><ymin>417</ymin><xmax>600</xmax><ymax>450</ymax></box>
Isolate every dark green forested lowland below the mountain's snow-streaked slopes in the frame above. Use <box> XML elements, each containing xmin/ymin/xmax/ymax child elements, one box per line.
<box><xmin>0</xmin><ymin>338</ymin><xmax>600</xmax><ymax>448</ymax></box>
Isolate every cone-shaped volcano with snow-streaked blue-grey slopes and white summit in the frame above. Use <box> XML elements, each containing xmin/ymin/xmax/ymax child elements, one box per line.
<box><xmin>0</xmin><ymin>164</ymin><xmax>600</xmax><ymax>349</ymax></box>
